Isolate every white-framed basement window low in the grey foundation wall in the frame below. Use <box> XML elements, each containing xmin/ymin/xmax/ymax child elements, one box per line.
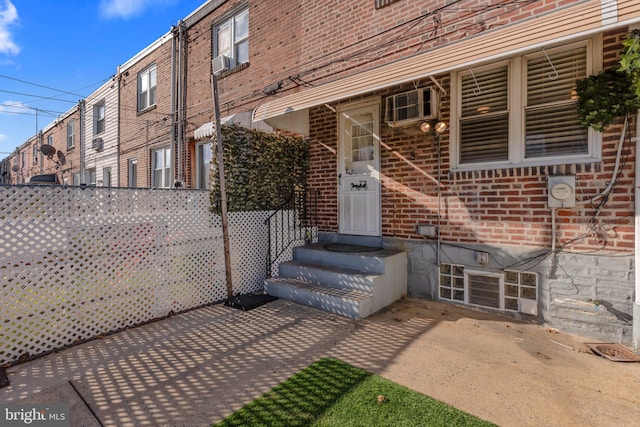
<box><xmin>439</xmin><ymin>264</ymin><xmax>538</xmax><ymax>315</ymax></box>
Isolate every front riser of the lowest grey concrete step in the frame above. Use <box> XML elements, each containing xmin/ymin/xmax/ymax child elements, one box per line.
<box><xmin>265</xmin><ymin>281</ymin><xmax>371</xmax><ymax>319</ymax></box>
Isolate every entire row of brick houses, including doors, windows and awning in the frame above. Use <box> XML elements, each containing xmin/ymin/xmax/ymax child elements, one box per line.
<box><xmin>3</xmin><ymin>0</ymin><xmax>640</xmax><ymax>346</ymax></box>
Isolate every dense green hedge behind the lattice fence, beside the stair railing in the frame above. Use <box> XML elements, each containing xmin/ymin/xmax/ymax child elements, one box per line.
<box><xmin>210</xmin><ymin>125</ymin><xmax>309</xmax><ymax>213</ymax></box>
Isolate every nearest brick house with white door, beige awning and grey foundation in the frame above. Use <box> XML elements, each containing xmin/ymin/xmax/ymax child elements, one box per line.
<box><xmin>250</xmin><ymin>0</ymin><xmax>640</xmax><ymax>345</ymax></box>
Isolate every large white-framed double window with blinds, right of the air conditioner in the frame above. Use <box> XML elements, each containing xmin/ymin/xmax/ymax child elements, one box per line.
<box><xmin>450</xmin><ymin>37</ymin><xmax>602</xmax><ymax>169</ymax></box>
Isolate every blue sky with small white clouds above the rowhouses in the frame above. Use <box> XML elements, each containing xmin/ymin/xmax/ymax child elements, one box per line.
<box><xmin>0</xmin><ymin>0</ymin><xmax>206</xmax><ymax>159</ymax></box>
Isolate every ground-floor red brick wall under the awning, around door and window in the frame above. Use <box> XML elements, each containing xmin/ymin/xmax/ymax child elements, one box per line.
<box><xmin>309</xmin><ymin>27</ymin><xmax>635</xmax><ymax>252</ymax></box>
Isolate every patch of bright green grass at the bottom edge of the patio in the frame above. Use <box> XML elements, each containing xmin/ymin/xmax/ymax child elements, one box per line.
<box><xmin>215</xmin><ymin>358</ymin><xmax>493</xmax><ymax>427</ymax></box>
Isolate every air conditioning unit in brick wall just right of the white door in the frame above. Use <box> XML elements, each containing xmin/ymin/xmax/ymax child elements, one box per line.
<box><xmin>385</xmin><ymin>88</ymin><xmax>438</xmax><ymax>127</ymax></box>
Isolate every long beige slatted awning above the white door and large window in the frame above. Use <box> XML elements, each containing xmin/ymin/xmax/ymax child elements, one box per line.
<box><xmin>253</xmin><ymin>0</ymin><xmax>640</xmax><ymax>129</ymax></box>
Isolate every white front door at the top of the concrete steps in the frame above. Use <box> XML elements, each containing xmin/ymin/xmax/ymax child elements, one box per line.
<box><xmin>338</xmin><ymin>101</ymin><xmax>381</xmax><ymax>236</ymax></box>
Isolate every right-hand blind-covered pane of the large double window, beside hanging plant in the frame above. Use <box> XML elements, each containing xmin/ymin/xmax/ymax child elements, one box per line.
<box><xmin>524</xmin><ymin>46</ymin><xmax>589</xmax><ymax>158</ymax></box>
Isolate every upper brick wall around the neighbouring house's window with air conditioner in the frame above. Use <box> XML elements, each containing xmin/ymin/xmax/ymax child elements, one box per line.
<box><xmin>186</xmin><ymin>0</ymin><xmax>302</xmax><ymax>127</ymax></box>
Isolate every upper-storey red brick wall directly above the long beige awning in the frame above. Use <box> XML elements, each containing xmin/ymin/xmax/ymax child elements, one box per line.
<box><xmin>288</xmin><ymin>0</ymin><xmax>578</xmax><ymax>88</ymax></box>
